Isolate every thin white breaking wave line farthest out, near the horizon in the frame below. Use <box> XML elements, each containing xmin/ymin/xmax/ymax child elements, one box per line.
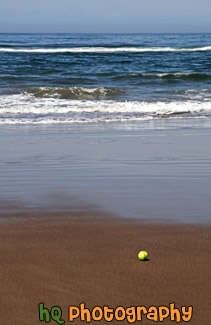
<box><xmin>0</xmin><ymin>46</ymin><xmax>211</xmax><ymax>53</ymax></box>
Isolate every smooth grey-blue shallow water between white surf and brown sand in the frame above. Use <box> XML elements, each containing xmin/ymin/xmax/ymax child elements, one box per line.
<box><xmin>0</xmin><ymin>119</ymin><xmax>211</xmax><ymax>223</ymax></box>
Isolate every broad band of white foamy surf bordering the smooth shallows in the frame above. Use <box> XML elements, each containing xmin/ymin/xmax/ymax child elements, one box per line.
<box><xmin>0</xmin><ymin>92</ymin><xmax>211</xmax><ymax>124</ymax></box>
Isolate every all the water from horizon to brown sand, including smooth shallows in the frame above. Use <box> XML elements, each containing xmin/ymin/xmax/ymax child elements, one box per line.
<box><xmin>0</xmin><ymin>34</ymin><xmax>211</xmax><ymax>223</ymax></box>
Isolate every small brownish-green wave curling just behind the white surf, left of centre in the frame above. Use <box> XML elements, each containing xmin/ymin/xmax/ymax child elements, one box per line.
<box><xmin>24</xmin><ymin>87</ymin><xmax>124</xmax><ymax>100</ymax></box>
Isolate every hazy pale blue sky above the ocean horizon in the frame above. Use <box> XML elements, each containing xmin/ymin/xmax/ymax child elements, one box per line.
<box><xmin>0</xmin><ymin>0</ymin><xmax>211</xmax><ymax>33</ymax></box>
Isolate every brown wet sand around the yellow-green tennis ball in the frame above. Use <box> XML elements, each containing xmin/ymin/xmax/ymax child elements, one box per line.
<box><xmin>0</xmin><ymin>211</ymin><xmax>211</xmax><ymax>325</ymax></box>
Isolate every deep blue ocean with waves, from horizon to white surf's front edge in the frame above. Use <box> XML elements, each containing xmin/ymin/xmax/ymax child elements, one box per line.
<box><xmin>0</xmin><ymin>34</ymin><xmax>211</xmax><ymax>124</ymax></box>
